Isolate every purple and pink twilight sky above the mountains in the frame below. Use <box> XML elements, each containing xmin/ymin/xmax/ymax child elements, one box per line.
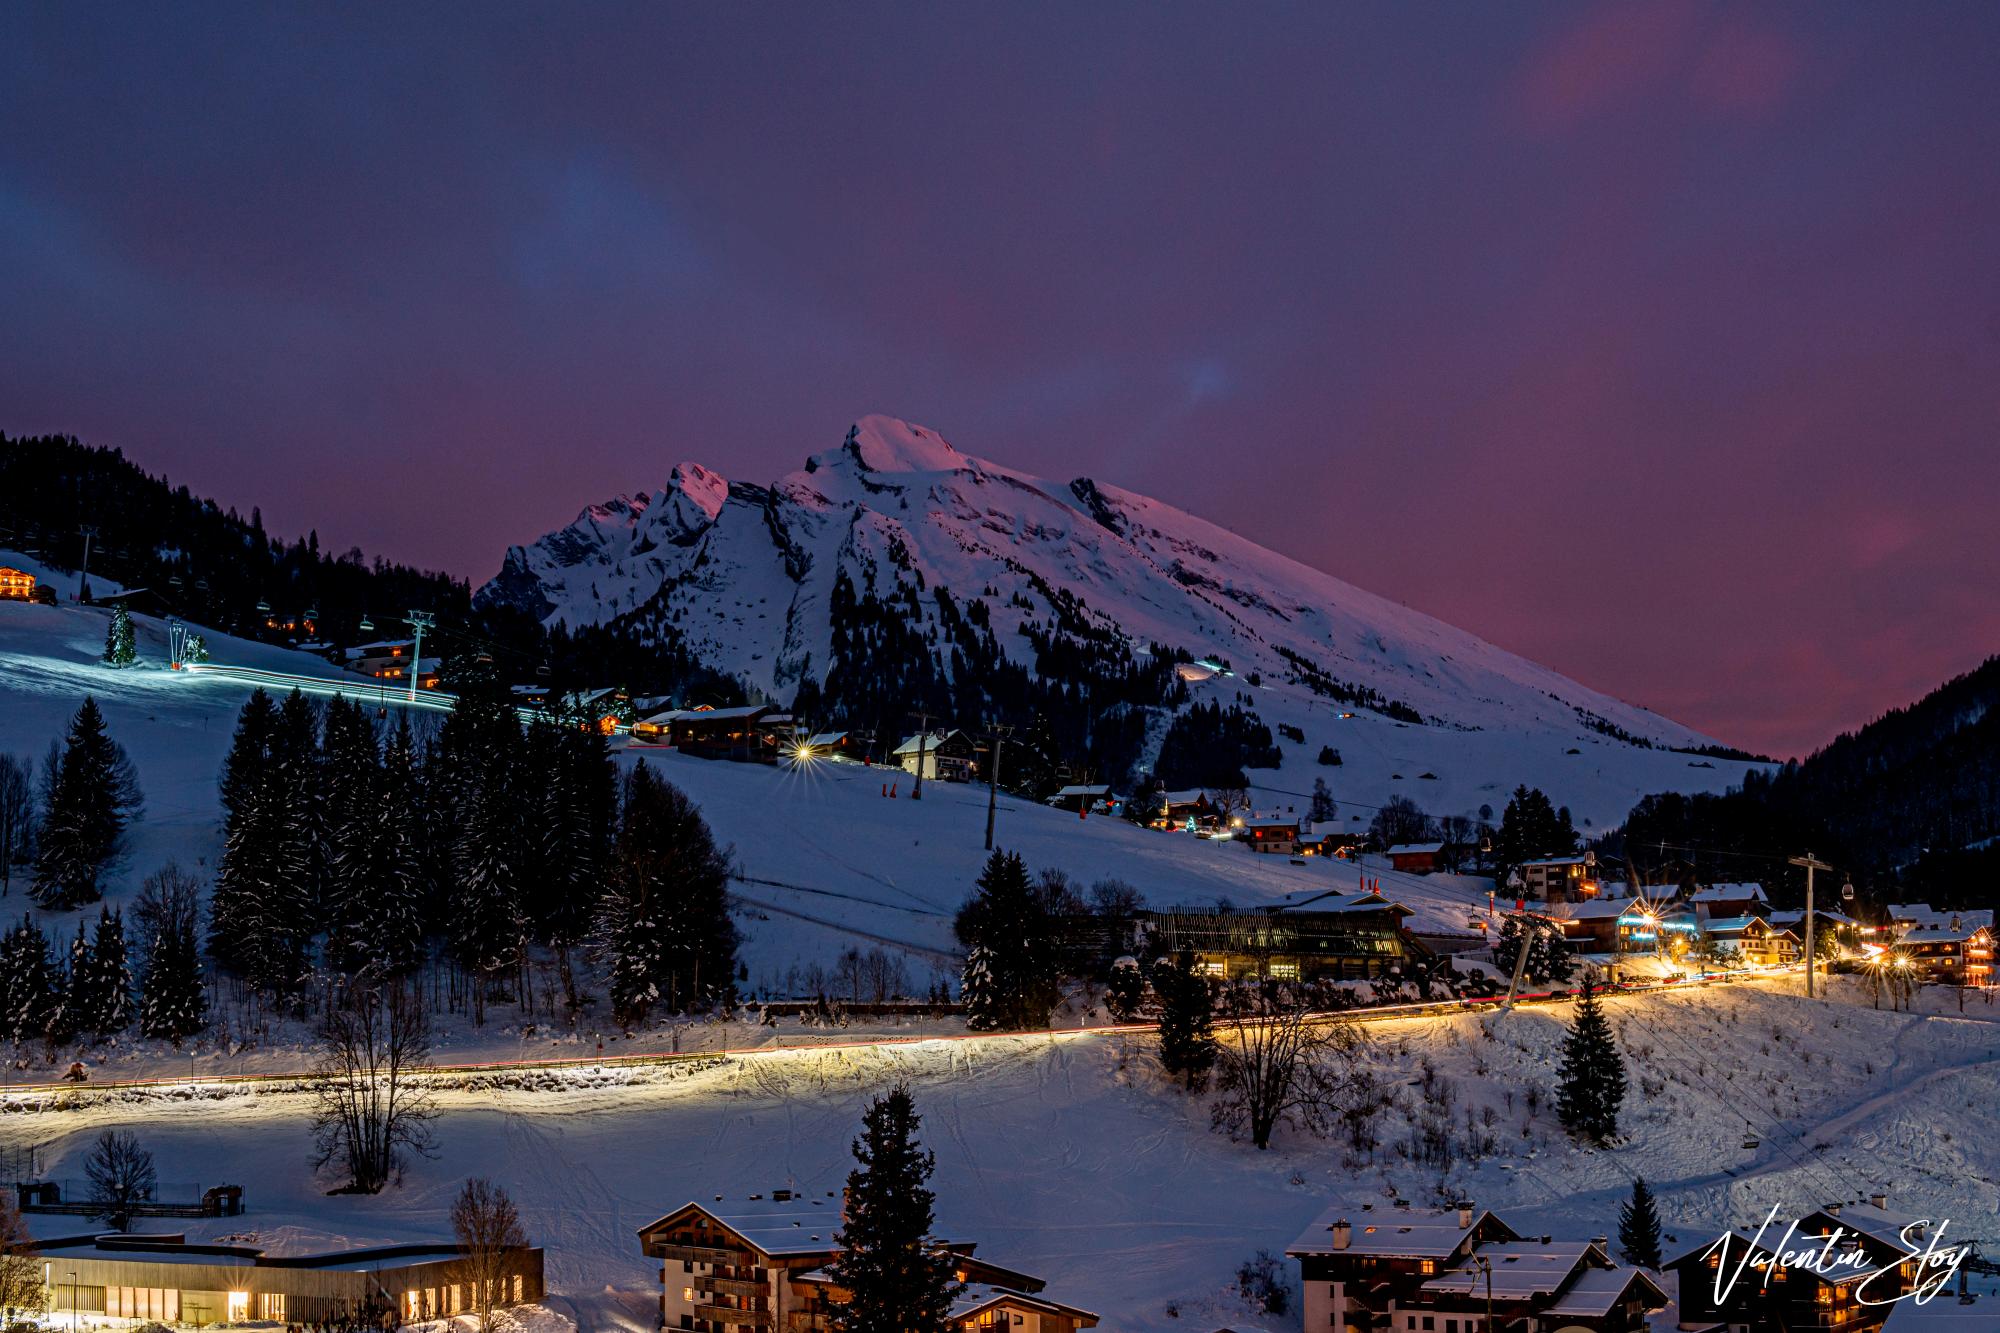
<box><xmin>0</xmin><ymin>0</ymin><xmax>2000</xmax><ymax>753</ymax></box>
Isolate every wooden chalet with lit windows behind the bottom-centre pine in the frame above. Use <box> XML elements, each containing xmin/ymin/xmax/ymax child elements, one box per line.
<box><xmin>638</xmin><ymin>1189</ymin><xmax>1098</xmax><ymax>1333</ymax></box>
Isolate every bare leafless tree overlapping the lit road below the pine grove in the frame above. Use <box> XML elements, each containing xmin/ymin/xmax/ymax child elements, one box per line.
<box><xmin>312</xmin><ymin>973</ymin><xmax>438</xmax><ymax>1195</ymax></box>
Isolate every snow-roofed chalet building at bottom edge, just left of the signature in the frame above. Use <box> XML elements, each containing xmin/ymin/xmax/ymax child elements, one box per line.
<box><xmin>1286</xmin><ymin>1203</ymin><xmax>1668</xmax><ymax>1333</ymax></box>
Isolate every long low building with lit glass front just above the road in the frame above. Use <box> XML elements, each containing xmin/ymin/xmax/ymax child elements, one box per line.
<box><xmin>1138</xmin><ymin>893</ymin><xmax>1430</xmax><ymax>981</ymax></box>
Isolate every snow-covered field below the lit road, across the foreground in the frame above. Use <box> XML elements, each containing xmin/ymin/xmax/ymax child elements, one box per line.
<box><xmin>0</xmin><ymin>983</ymin><xmax>2000</xmax><ymax>1331</ymax></box>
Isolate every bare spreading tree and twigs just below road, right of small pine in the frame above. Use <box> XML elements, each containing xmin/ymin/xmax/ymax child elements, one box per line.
<box><xmin>1214</xmin><ymin>981</ymin><xmax>1368</xmax><ymax>1149</ymax></box>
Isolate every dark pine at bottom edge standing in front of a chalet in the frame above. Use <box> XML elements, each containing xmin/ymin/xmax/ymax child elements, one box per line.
<box><xmin>828</xmin><ymin>1085</ymin><xmax>962</xmax><ymax>1333</ymax></box>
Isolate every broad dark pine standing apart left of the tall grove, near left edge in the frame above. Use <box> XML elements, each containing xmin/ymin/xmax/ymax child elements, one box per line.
<box><xmin>30</xmin><ymin>697</ymin><xmax>140</xmax><ymax>911</ymax></box>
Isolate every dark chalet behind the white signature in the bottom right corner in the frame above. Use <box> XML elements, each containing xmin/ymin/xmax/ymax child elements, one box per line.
<box><xmin>1666</xmin><ymin>1195</ymin><xmax>1926</xmax><ymax>1333</ymax></box>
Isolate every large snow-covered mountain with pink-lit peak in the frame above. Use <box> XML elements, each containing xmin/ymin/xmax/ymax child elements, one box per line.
<box><xmin>478</xmin><ymin>416</ymin><xmax>1768</xmax><ymax>815</ymax></box>
